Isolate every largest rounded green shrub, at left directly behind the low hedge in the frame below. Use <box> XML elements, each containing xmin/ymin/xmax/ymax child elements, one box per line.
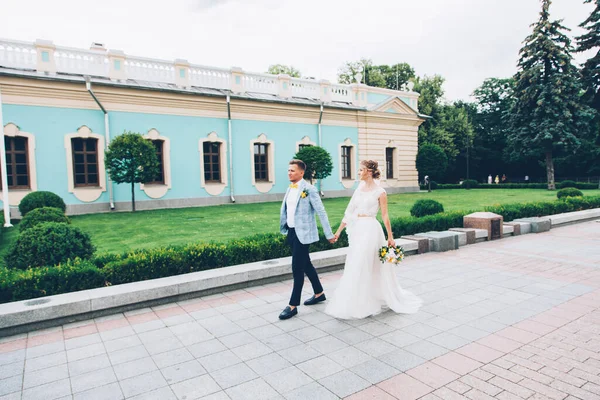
<box><xmin>4</xmin><ymin>222</ymin><xmax>96</xmax><ymax>269</ymax></box>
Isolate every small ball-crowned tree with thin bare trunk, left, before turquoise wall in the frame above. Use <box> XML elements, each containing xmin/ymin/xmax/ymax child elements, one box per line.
<box><xmin>105</xmin><ymin>132</ymin><xmax>160</xmax><ymax>211</ymax></box>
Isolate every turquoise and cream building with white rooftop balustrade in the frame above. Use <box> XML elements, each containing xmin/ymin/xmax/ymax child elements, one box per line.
<box><xmin>0</xmin><ymin>40</ymin><xmax>424</xmax><ymax>217</ymax></box>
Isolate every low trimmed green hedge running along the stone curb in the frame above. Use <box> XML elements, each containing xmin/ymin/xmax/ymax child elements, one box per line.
<box><xmin>0</xmin><ymin>196</ymin><xmax>600</xmax><ymax>302</ymax></box>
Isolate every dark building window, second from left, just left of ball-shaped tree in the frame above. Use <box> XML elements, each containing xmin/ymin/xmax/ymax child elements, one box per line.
<box><xmin>71</xmin><ymin>138</ymin><xmax>99</xmax><ymax>187</ymax></box>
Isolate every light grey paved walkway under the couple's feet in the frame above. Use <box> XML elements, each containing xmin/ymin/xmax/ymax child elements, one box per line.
<box><xmin>0</xmin><ymin>222</ymin><xmax>600</xmax><ymax>400</ymax></box>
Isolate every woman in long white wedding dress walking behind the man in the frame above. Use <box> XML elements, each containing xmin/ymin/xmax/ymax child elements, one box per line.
<box><xmin>325</xmin><ymin>160</ymin><xmax>422</xmax><ymax>319</ymax></box>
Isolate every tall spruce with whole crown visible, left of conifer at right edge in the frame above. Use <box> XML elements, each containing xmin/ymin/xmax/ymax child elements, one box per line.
<box><xmin>508</xmin><ymin>0</ymin><xmax>593</xmax><ymax>189</ymax></box>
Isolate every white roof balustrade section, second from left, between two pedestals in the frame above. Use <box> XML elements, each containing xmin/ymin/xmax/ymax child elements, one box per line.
<box><xmin>54</xmin><ymin>47</ymin><xmax>108</xmax><ymax>76</ymax></box>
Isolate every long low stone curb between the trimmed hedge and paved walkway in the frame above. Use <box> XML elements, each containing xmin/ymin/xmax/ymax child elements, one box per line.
<box><xmin>0</xmin><ymin>208</ymin><xmax>600</xmax><ymax>337</ymax></box>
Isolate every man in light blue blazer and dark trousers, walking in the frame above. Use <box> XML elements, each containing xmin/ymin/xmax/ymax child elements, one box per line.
<box><xmin>279</xmin><ymin>160</ymin><xmax>335</xmax><ymax>319</ymax></box>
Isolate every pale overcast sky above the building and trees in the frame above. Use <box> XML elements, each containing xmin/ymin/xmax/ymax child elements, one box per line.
<box><xmin>0</xmin><ymin>0</ymin><xmax>593</xmax><ymax>100</ymax></box>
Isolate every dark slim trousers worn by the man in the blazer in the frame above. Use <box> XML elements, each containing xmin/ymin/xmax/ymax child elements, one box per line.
<box><xmin>288</xmin><ymin>228</ymin><xmax>323</xmax><ymax>306</ymax></box>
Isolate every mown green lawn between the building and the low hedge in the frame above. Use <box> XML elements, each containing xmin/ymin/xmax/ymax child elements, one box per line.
<box><xmin>0</xmin><ymin>189</ymin><xmax>600</xmax><ymax>258</ymax></box>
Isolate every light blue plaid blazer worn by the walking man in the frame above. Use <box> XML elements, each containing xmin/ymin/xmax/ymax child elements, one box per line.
<box><xmin>279</xmin><ymin>179</ymin><xmax>333</xmax><ymax>244</ymax></box>
